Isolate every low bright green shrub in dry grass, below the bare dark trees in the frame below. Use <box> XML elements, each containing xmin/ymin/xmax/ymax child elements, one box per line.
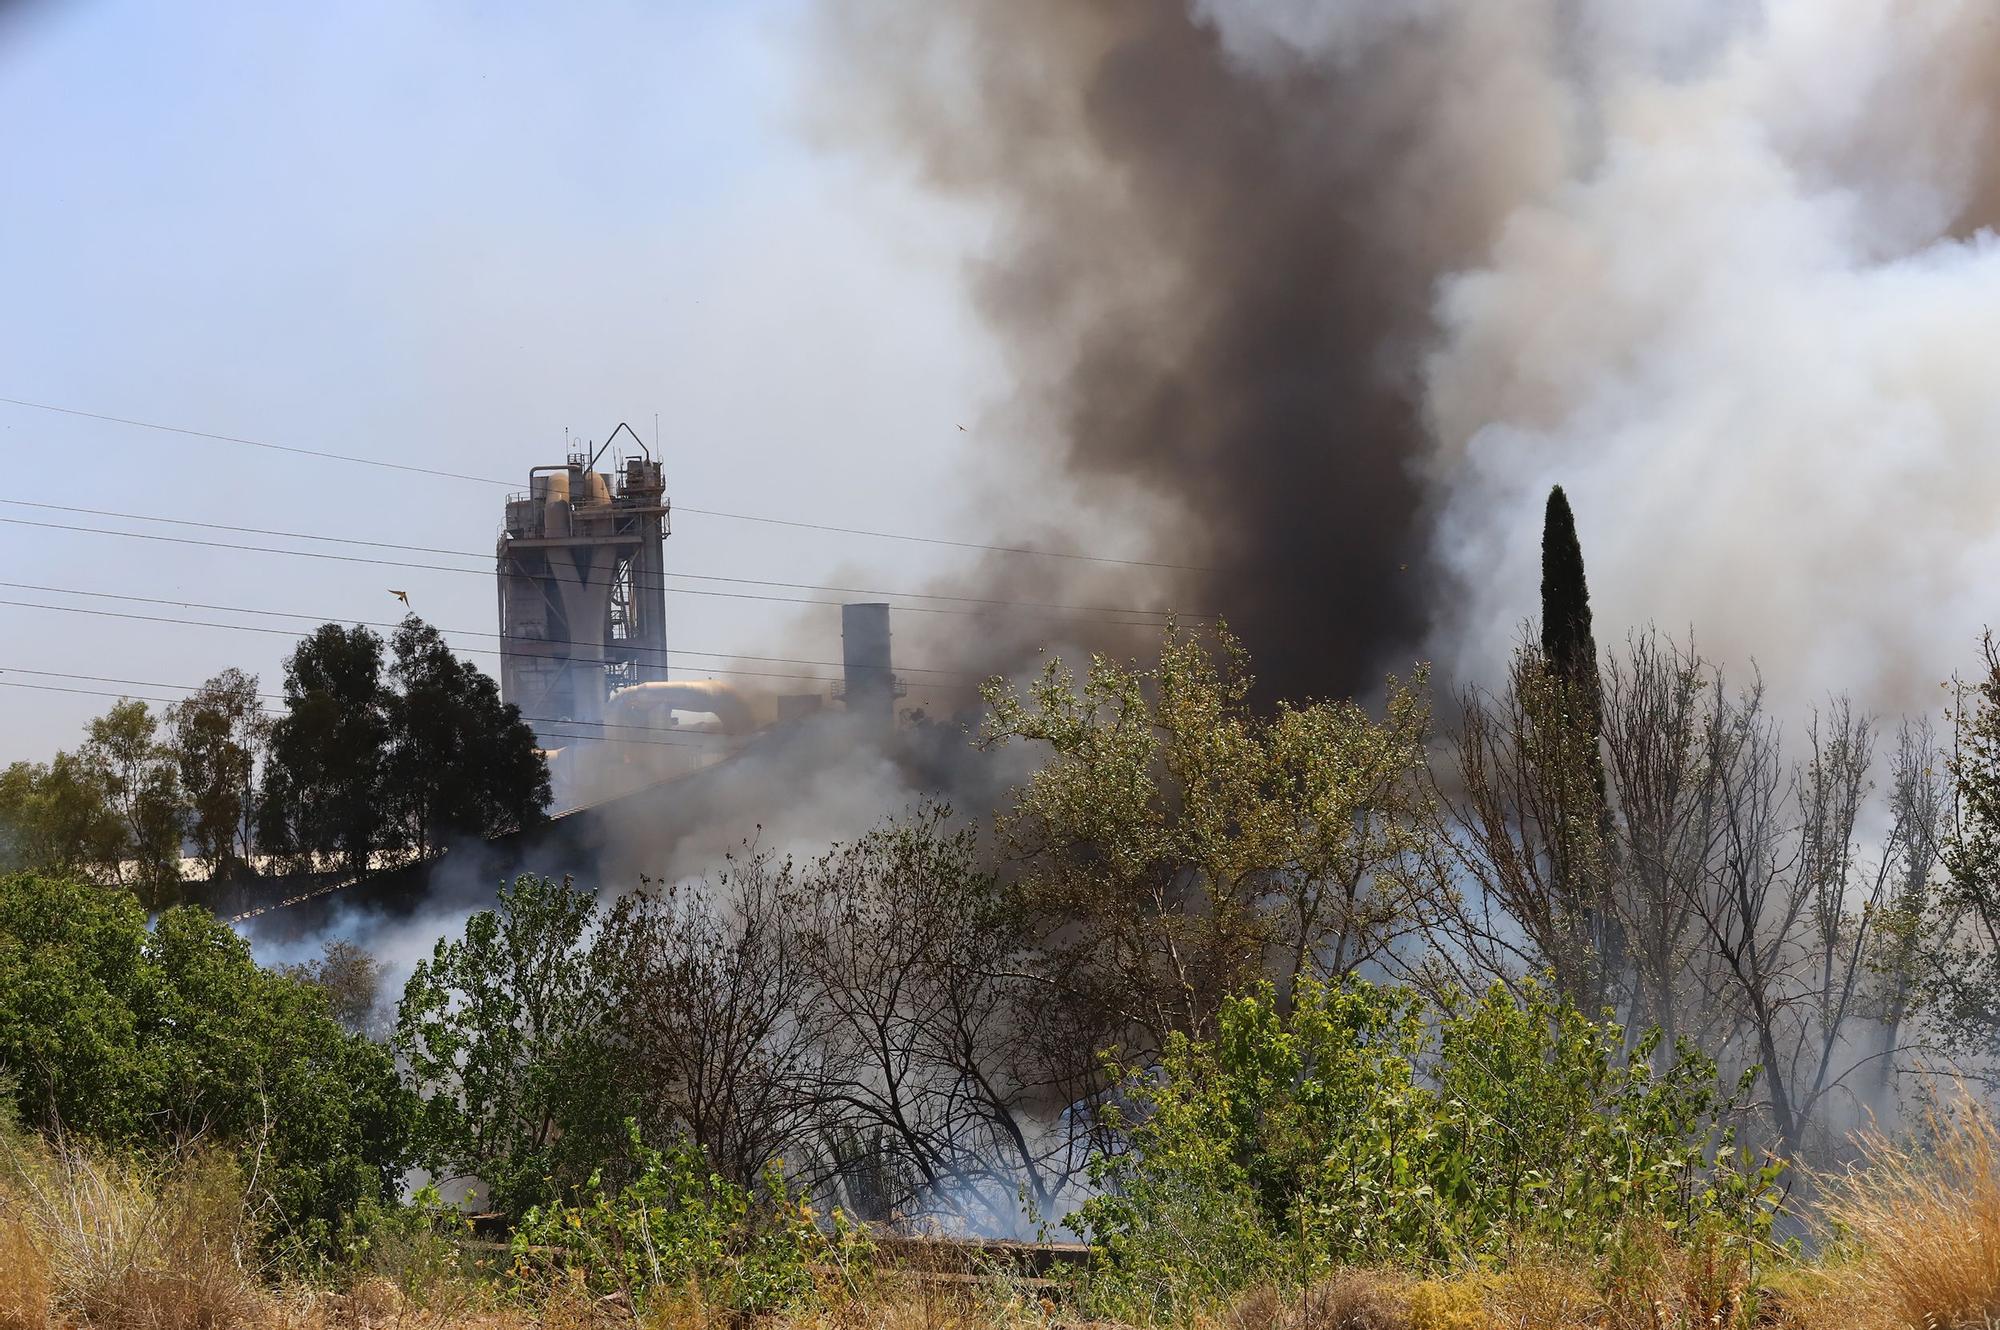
<box><xmin>512</xmin><ymin>1128</ymin><xmax>868</xmax><ymax>1314</ymax></box>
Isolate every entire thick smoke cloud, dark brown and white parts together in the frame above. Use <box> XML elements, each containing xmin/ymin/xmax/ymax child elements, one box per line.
<box><xmin>832</xmin><ymin>0</ymin><xmax>2000</xmax><ymax>708</ymax></box>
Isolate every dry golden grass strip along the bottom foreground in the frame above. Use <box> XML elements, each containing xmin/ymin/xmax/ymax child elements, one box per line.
<box><xmin>19</xmin><ymin>1106</ymin><xmax>2000</xmax><ymax>1330</ymax></box>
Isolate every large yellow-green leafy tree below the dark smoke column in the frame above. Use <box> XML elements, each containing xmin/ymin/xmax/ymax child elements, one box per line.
<box><xmin>982</xmin><ymin>630</ymin><xmax>1428</xmax><ymax>1046</ymax></box>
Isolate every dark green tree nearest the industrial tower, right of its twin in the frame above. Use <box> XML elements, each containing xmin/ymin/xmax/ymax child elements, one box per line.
<box><xmin>386</xmin><ymin>614</ymin><xmax>550</xmax><ymax>854</ymax></box>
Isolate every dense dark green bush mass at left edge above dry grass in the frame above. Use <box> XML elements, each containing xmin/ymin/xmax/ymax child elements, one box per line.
<box><xmin>0</xmin><ymin>874</ymin><xmax>410</xmax><ymax>1256</ymax></box>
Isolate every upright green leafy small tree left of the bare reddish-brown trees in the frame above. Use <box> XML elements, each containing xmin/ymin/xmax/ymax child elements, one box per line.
<box><xmin>394</xmin><ymin>876</ymin><xmax>626</xmax><ymax>1214</ymax></box>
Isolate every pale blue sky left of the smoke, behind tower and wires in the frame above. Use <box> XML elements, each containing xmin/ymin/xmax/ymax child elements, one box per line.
<box><xmin>0</xmin><ymin>0</ymin><xmax>1006</xmax><ymax>760</ymax></box>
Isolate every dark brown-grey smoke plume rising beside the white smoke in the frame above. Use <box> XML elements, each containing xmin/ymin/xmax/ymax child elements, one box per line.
<box><xmin>830</xmin><ymin>0</ymin><xmax>1542</xmax><ymax>698</ymax></box>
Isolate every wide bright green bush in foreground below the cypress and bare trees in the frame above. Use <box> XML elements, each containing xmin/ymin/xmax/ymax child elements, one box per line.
<box><xmin>1078</xmin><ymin>982</ymin><xmax>1776</xmax><ymax>1310</ymax></box>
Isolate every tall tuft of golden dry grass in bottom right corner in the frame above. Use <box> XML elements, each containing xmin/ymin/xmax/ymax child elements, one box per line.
<box><xmin>1820</xmin><ymin>1098</ymin><xmax>2000</xmax><ymax>1330</ymax></box>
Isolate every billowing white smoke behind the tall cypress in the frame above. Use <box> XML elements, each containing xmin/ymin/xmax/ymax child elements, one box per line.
<box><xmin>1424</xmin><ymin>0</ymin><xmax>2000</xmax><ymax>710</ymax></box>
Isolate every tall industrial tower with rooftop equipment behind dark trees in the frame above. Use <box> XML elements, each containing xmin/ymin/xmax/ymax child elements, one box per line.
<box><xmin>496</xmin><ymin>434</ymin><xmax>670</xmax><ymax>748</ymax></box>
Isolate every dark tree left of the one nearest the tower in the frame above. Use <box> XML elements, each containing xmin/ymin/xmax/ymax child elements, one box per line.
<box><xmin>256</xmin><ymin>624</ymin><xmax>390</xmax><ymax>874</ymax></box>
